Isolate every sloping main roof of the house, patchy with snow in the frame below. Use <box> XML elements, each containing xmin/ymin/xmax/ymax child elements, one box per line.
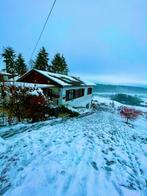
<box><xmin>34</xmin><ymin>69</ymin><xmax>95</xmax><ymax>86</ymax></box>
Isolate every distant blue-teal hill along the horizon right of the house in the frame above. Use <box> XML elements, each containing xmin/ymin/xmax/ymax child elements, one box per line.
<box><xmin>94</xmin><ymin>84</ymin><xmax>147</xmax><ymax>94</ymax></box>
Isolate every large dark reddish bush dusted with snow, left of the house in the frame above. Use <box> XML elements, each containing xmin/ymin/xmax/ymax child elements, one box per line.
<box><xmin>4</xmin><ymin>86</ymin><xmax>47</xmax><ymax>124</ymax></box>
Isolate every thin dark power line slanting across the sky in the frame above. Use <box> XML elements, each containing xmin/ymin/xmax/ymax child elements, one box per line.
<box><xmin>30</xmin><ymin>0</ymin><xmax>57</xmax><ymax>59</ymax></box>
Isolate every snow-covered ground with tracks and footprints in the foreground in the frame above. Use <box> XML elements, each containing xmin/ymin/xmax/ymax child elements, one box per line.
<box><xmin>0</xmin><ymin>97</ymin><xmax>147</xmax><ymax>196</ymax></box>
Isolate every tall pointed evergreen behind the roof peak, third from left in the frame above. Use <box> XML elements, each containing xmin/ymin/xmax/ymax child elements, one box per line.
<box><xmin>34</xmin><ymin>47</ymin><xmax>49</xmax><ymax>71</ymax></box>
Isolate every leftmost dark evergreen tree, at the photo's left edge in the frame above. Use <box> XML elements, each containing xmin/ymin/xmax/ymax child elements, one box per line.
<box><xmin>1</xmin><ymin>47</ymin><xmax>16</xmax><ymax>76</ymax></box>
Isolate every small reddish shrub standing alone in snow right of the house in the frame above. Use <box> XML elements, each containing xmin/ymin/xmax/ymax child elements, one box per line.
<box><xmin>120</xmin><ymin>107</ymin><xmax>142</xmax><ymax>123</ymax></box>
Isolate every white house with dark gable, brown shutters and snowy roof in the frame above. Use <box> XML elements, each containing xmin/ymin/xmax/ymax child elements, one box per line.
<box><xmin>17</xmin><ymin>69</ymin><xmax>95</xmax><ymax>107</ymax></box>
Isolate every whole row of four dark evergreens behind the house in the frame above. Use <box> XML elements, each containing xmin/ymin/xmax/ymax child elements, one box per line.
<box><xmin>1</xmin><ymin>47</ymin><xmax>68</xmax><ymax>76</ymax></box>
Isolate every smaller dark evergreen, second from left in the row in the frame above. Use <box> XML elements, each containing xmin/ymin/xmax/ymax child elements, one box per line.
<box><xmin>16</xmin><ymin>54</ymin><xmax>27</xmax><ymax>76</ymax></box>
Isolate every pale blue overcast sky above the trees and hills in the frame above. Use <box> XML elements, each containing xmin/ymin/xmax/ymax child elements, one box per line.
<box><xmin>0</xmin><ymin>0</ymin><xmax>147</xmax><ymax>84</ymax></box>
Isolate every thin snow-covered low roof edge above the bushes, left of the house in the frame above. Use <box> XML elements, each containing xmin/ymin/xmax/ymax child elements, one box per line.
<box><xmin>5</xmin><ymin>82</ymin><xmax>55</xmax><ymax>88</ymax></box>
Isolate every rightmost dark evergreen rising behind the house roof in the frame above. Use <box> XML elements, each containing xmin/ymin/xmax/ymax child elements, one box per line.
<box><xmin>51</xmin><ymin>53</ymin><xmax>68</xmax><ymax>75</ymax></box>
